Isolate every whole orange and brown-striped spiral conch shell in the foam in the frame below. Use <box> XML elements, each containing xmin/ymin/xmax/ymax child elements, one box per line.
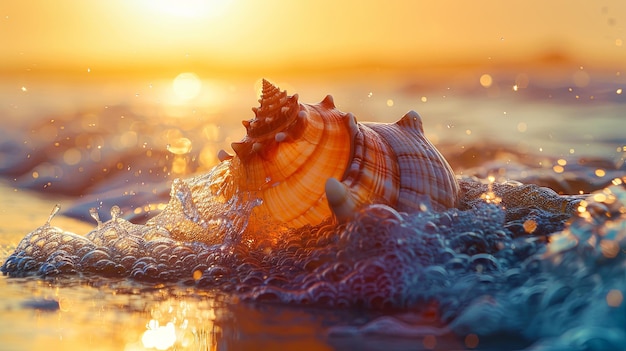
<box><xmin>219</xmin><ymin>80</ymin><xmax>459</xmax><ymax>228</ymax></box>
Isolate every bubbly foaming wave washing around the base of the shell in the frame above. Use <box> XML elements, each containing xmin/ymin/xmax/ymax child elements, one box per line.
<box><xmin>2</xmin><ymin>172</ymin><xmax>626</xmax><ymax>349</ymax></box>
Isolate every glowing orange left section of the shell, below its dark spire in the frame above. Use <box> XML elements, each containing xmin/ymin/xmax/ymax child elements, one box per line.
<box><xmin>233</xmin><ymin>81</ymin><xmax>353</xmax><ymax>227</ymax></box>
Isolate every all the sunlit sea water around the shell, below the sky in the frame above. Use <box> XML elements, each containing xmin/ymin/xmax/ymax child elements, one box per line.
<box><xmin>0</xmin><ymin>71</ymin><xmax>626</xmax><ymax>350</ymax></box>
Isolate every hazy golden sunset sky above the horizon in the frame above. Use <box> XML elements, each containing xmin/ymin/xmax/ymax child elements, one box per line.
<box><xmin>0</xmin><ymin>0</ymin><xmax>626</xmax><ymax>77</ymax></box>
